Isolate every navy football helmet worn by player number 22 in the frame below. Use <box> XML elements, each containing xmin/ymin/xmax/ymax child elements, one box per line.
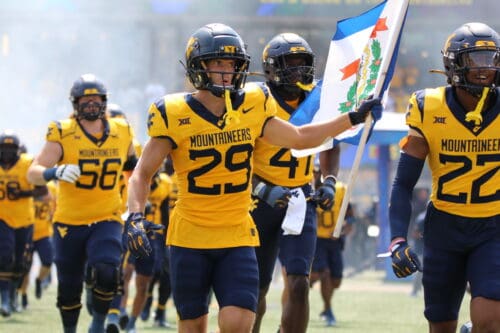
<box><xmin>441</xmin><ymin>23</ymin><xmax>500</xmax><ymax>96</ymax></box>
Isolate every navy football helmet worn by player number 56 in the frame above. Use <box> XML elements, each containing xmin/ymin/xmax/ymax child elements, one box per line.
<box><xmin>69</xmin><ymin>74</ymin><xmax>108</xmax><ymax>120</ymax></box>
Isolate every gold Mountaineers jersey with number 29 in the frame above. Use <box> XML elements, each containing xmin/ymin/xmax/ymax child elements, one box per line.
<box><xmin>148</xmin><ymin>84</ymin><xmax>275</xmax><ymax>249</ymax></box>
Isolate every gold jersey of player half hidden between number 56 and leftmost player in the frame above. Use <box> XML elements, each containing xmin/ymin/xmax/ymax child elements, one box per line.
<box><xmin>33</xmin><ymin>181</ymin><xmax>56</xmax><ymax>241</ymax></box>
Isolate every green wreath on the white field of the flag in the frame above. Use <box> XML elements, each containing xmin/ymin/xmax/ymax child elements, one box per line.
<box><xmin>339</xmin><ymin>39</ymin><xmax>382</xmax><ymax>113</ymax></box>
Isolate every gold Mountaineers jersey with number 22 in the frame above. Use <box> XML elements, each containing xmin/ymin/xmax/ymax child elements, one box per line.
<box><xmin>406</xmin><ymin>87</ymin><xmax>500</xmax><ymax>217</ymax></box>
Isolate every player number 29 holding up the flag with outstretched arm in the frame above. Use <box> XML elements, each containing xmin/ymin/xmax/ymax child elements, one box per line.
<box><xmin>127</xmin><ymin>23</ymin><xmax>380</xmax><ymax>332</ymax></box>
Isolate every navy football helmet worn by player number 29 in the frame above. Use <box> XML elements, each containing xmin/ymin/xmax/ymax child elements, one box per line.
<box><xmin>185</xmin><ymin>23</ymin><xmax>250</xmax><ymax>97</ymax></box>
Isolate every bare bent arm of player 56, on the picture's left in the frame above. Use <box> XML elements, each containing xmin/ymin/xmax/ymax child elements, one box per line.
<box><xmin>27</xmin><ymin>141</ymin><xmax>63</xmax><ymax>185</ymax></box>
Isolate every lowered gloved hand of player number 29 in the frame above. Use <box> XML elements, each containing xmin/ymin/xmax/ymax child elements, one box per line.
<box><xmin>125</xmin><ymin>213</ymin><xmax>152</xmax><ymax>258</ymax></box>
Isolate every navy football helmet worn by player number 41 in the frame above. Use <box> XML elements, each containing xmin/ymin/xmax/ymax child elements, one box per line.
<box><xmin>262</xmin><ymin>33</ymin><xmax>314</xmax><ymax>93</ymax></box>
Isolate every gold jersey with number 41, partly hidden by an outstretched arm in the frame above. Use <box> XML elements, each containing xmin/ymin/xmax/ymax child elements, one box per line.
<box><xmin>254</xmin><ymin>83</ymin><xmax>314</xmax><ymax>187</ymax></box>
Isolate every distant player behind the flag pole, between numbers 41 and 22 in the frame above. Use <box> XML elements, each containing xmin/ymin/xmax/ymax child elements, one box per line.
<box><xmin>311</xmin><ymin>167</ymin><xmax>355</xmax><ymax>326</ymax></box>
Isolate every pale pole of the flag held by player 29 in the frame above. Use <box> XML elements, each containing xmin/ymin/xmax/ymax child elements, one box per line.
<box><xmin>333</xmin><ymin>0</ymin><xmax>409</xmax><ymax>238</ymax></box>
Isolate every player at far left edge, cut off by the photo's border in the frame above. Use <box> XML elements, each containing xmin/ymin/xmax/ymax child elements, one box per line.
<box><xmin>0</xmin><ymin>131</ymin><xmax>47</xmax><ymax>317</ymax></box>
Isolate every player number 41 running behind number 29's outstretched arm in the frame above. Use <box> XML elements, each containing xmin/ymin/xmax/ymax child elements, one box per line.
<box><xmin>252</xmin><ymin>33</ymin><xmax>340</xmax><ymax>332</ymax></box>
